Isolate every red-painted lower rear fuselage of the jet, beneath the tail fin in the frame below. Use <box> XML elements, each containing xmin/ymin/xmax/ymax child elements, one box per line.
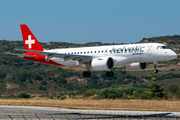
<box><xmin>23</xmin><ymin>53</ymin><xmax>65</xmax><ymax>66</ymax></box>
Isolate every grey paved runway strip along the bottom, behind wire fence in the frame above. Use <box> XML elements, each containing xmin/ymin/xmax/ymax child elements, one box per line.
<box><xmin>0</xmin><ymin>105</ymin><xmax>180</xmax><ymax>120</ymax></box>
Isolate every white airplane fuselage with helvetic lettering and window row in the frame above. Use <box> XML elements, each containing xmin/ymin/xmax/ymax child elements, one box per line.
<box><xmin>39</xmin><ymin>43</ymin><xmax>177</xmax><ymax>67</ymax></box>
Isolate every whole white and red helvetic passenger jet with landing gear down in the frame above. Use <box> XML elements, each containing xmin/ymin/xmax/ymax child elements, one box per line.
<box><xmin>6</xmin><ymin>24</ymin><xmax>177</xmax><ymax>77</ymax></box>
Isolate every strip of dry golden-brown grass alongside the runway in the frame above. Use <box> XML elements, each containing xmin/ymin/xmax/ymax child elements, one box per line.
<box><xmin>0</xmin><ymin>99</ymin><xmax>180</xmax><ymax>111</ymax></box>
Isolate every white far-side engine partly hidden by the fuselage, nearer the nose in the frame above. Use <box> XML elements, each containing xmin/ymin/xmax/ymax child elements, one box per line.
<box><xmin>126</xmin><ymin>63</ymin><xmax>147</xmax><ymax>71</ymax></box>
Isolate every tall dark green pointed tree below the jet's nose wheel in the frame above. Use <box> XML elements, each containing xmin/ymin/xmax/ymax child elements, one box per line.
<box><xmin>148</xmin><ymin>77</ymin><xmax>164</xmax><ymax>98</ymax></box>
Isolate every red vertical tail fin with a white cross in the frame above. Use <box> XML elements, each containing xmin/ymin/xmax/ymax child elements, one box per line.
<box><xmin>20</xmin><ymin>24</ymin><xmax>44</xmax><ymax>51</ymax></box>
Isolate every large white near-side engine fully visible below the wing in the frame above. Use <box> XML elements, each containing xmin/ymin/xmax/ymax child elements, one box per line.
<box><xmin>91</xmin><ymin>57</ymin><xmax>114</xmax><ymax>71</ymax></box>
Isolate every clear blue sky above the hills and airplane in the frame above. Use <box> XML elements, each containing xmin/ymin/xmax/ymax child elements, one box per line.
<box><xmin>0</xmin><ymin>0</ymin><xmax>180</xmax><ymax>43</ymax></box>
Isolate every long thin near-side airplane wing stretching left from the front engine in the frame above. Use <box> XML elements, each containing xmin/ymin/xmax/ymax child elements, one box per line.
<box><xmin>15</xmin><ymin>49</ymin><xmax>92</xmax><ymax>61</ymax></box>
